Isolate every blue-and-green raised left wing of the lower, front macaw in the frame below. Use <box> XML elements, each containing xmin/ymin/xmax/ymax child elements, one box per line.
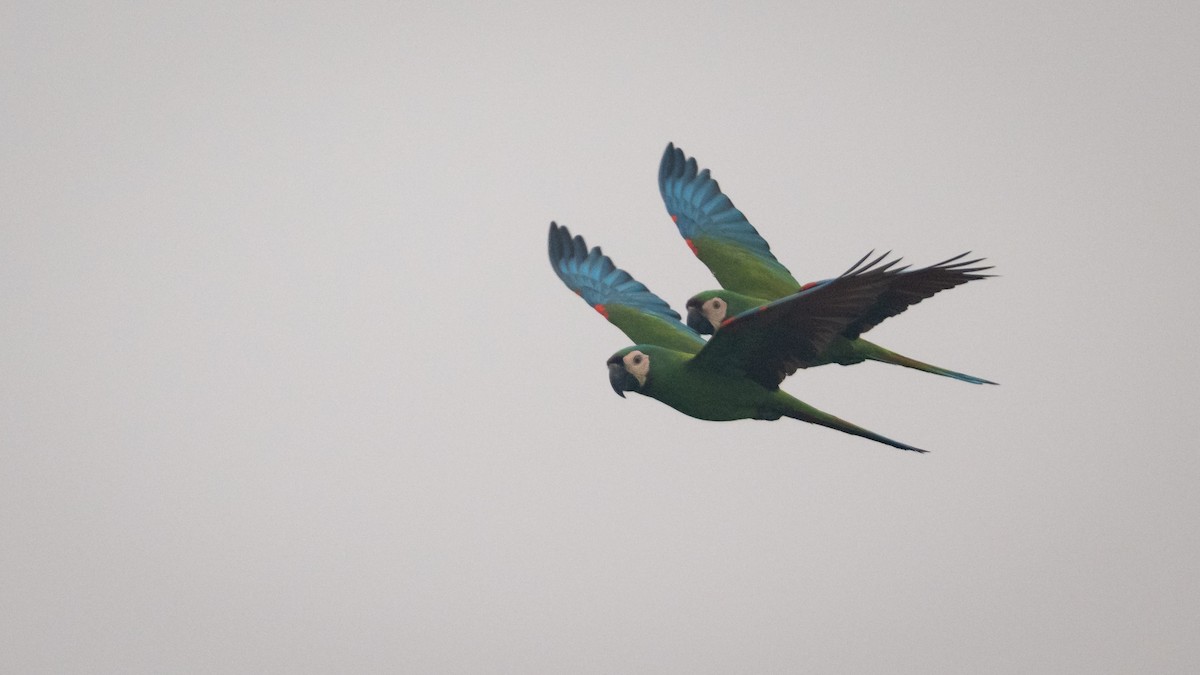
<box><xmin>548</xmin><ymin>222</ymin><xmax>704</xmax><ymax>354</ymax></box>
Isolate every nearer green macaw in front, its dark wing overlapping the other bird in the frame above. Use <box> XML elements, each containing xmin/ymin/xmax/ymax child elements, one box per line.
<box><xmin>548</xmin><ymin>222</ymin><xmax>926</xmax><ymax>453</ymax></box>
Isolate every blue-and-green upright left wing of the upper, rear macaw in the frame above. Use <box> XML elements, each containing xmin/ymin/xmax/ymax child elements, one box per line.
<box><xmin>659</xmin><ymin>143</ymin><xmax>800</xmax><ymax>298</ymax></box>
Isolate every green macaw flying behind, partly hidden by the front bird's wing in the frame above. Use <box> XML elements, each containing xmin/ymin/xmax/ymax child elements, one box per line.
<box><xmin>659</xmin><ymin>143</ymin><xmax>995</xmax><ymax>384</ymax></box>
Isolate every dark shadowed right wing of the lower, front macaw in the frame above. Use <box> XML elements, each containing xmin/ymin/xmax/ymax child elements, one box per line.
<box><xmin>688</xmin><ymin>253</ymin><xmax>906</xmax><ymax>389</ymax></box>
